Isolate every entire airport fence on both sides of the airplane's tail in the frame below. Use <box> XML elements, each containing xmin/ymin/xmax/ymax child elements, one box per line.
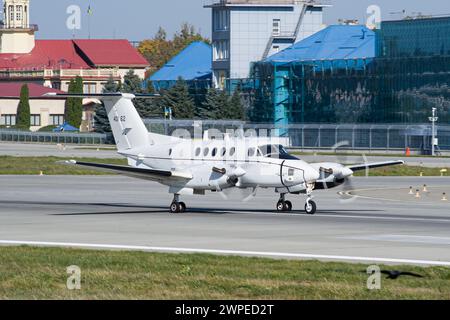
<box><xmin>0</xmin><ymin>119</ymin><xmax>450</xmax><ymax>154</ymax></box>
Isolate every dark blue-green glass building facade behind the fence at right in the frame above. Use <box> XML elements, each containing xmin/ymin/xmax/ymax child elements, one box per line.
<box><xmin>244</xmin><ymin>18</ymin><xmax>450</xmax><ymax>125</ymax></box>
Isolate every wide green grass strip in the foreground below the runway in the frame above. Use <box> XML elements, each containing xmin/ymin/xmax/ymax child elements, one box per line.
<box><xmin>0</xmin><ymin>247</ymin><xmax>450</xmax><ymax>299</ymax></box>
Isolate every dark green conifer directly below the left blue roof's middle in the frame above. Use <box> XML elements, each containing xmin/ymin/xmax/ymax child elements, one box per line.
<box><xmin>161</xmin><ymin>78</ymin><xmax>195</xmax><ymax>119</ymax></box>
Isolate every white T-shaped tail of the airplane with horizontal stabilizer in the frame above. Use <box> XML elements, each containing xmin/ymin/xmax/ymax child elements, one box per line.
<box><xmin>47</xmin><ymin>93</ymin><xmax>169</xmax><ymax>151</ymax></box>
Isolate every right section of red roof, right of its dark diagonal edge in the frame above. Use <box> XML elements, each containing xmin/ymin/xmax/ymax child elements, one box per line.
<box><xmin>74</xmin><ymin>40</ymin><xmax>149</xmax><ymax>67</ymax></box>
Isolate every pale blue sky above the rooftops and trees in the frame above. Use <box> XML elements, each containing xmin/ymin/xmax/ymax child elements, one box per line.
<box><xmin>23</xmin><ymin>0</ymin><xmax>450</xmax><ymax>40</ymax></box>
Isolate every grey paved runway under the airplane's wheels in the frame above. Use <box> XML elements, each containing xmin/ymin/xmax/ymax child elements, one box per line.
<box><xmin>0</xmin><ymin>176</ymin><xmax>450</xmax><ymax>265</ymax></box>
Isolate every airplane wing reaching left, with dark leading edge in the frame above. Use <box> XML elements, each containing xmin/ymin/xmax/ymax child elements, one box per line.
<box><xmin>57</xmin><ymin>160</ymin><xmax>192</xmax><ymax>182</ymax></box>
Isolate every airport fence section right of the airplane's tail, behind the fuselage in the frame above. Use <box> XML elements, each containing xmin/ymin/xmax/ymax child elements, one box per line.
<box><xmin>145</xmin><ymin>119</ymin><xmax>450</xmax><ymax>154</ymax></box>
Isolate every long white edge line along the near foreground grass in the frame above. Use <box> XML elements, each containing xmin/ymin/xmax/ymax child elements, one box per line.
<box><xmin>0</xmin><ymin>240</ymin><xmax>450</xmax><ymax>267</ymax></box>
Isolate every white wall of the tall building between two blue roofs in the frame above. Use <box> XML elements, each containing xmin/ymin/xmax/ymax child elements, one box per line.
<box><xmin>212</xmin><ymin>3</ymin><xmax>324</xmax><ymax>86</ymax></box>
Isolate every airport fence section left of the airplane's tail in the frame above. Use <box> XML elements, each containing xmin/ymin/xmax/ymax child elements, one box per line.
<box><xmin>0</xmin><ymin>130</ymin><xmax>110</xmax><ymax>145</ymax></box>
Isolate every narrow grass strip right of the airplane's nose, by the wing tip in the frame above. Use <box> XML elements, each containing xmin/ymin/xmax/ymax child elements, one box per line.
<box><xmin>355</xmin><ymin>165</ymin><xmax>450</xmax><ymax>177</ymax></box>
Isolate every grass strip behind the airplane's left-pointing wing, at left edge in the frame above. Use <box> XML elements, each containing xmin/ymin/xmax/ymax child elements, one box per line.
<box><xmin>0</xmin><ymin>156</ymin><xmax>127</xmax><ymax>175</ymax></box>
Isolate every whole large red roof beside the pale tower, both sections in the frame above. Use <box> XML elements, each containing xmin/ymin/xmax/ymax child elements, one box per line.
<box><xmin>0</xmin><ymin>40</ymin><xmax>148</xmax><ymax>70</ymax></box>
